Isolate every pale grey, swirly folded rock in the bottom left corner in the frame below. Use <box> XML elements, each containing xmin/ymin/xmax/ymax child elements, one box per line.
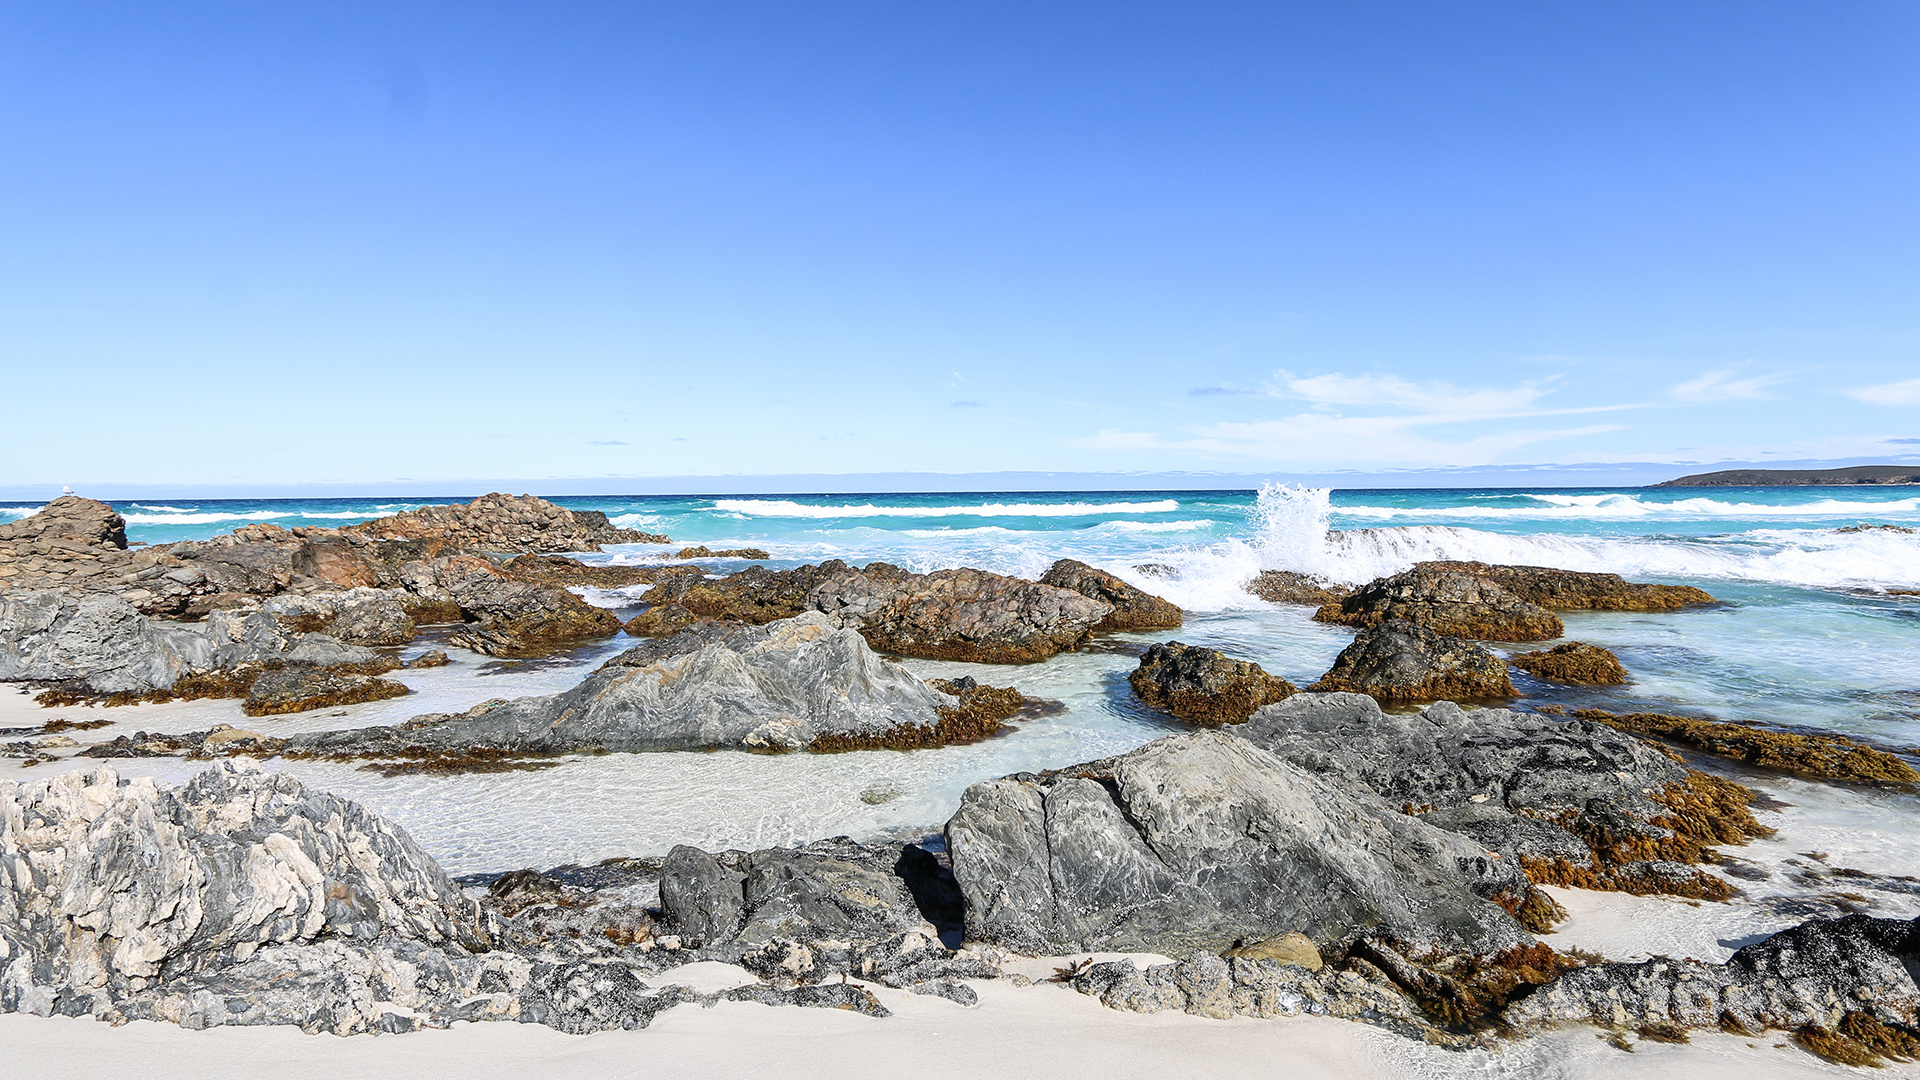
<box><xmin>0</xmin><ymin>763</ymin><xmax>482</xmax><ymax>1015</ymax></box>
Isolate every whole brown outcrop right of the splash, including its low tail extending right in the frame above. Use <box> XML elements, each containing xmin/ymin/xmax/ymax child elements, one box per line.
<box><xmin>1313</xmin><ymin>561</ymin><xmax>1715</xmax><ymax>642</ymax></box>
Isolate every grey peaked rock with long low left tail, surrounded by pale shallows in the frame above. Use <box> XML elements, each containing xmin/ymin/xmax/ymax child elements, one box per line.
<box><xmin>296</xmin><ymin>613</ymin><xmax>975</xmax><ymax>757</ymax></box>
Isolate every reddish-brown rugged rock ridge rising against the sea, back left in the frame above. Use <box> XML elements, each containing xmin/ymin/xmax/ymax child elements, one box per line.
<box><xmin>340</xmin><ymin>492</ymin><xmax>666</xmax><ymax>553</ymax></box>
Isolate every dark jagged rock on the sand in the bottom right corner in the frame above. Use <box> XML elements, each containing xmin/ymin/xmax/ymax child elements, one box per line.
<box><xmin>1503</xmin><ymin>915</ymin><xmax>1920</xmax><ymax>1065</ymax></box>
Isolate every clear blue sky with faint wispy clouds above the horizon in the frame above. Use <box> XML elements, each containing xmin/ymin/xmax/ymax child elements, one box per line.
<box><xmin>0</xmin><ymin>0</ymin><xmax>1920</xmax><ymax>488</ymax></box>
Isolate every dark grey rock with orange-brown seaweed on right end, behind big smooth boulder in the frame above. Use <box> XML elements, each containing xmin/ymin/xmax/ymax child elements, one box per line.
<box><xmin>1227</xmin><ymin>694</ymin><xmax>1768</xmax><ymax>907</ymax></box>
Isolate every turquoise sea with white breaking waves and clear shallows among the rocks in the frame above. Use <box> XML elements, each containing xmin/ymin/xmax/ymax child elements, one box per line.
<box><xmin>0</xmin><ymin>486</ymin><xmax>1920</xmax><ymax>887</ymax></box>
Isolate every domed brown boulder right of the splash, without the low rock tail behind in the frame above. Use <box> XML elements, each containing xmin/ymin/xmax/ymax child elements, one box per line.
<box><xmin>1313</xmin><ymin>563</ymin><xmax>1565</xmax><ymax>642</ymax></box>
